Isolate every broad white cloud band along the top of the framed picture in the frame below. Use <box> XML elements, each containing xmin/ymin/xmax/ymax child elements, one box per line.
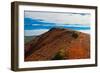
<box><xmin>25</xmin><ymin>11</ymin><xmax>90</xmax><ymax>25</ymax></box>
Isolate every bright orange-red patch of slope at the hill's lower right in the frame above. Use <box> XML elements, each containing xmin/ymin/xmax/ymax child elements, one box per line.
<box><xmin>67</xmin><ymin>33</ymin><xmax>90</xmax><ymax>59</ymax></box>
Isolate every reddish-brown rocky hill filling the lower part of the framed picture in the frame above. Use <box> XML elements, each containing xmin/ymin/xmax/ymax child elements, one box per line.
<box><xmin>25</xmin><ymin>28</ymin><xmax>90</xmax><ymax>61</ymax></box>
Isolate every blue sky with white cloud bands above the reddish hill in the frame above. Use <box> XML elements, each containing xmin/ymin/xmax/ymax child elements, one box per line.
<box><xmin>24</xmin><ymin>11</ymin><xmax>91</xmax><ymax>36</ymax></box>
